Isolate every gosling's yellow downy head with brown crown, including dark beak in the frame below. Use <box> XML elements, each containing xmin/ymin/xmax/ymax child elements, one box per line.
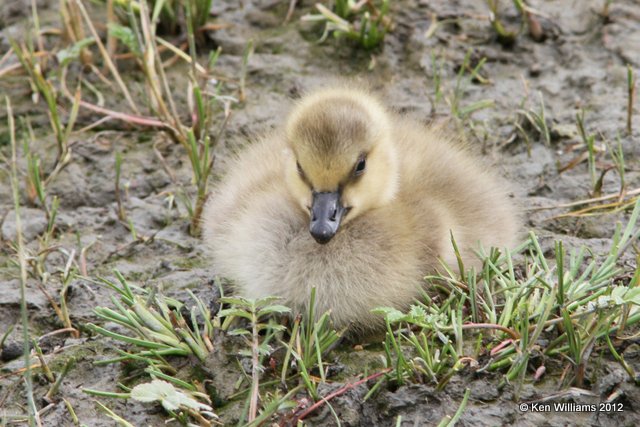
<box><xmin>286</xmin><ymin>88</ymin><xmax>398</xmax><ymax>244</ymax></box>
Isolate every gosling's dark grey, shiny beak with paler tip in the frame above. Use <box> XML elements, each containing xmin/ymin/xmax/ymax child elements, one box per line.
<box><xmin>309</xmin><ymin>191</ymin><xmax>345</xmax><ymax>244</ymax></box>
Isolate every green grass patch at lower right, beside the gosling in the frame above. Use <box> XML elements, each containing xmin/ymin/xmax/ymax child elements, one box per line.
<box><xmin>376</xmin><ymin>201</ymin><xmax>640</xmax><ymax>394</ymax></box>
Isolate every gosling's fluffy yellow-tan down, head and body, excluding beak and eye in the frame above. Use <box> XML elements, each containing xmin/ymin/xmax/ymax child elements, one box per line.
<box><xmin>203</xmin><ymin>88</ymin><xmax>518</xmax><ymax>333</ymax></box>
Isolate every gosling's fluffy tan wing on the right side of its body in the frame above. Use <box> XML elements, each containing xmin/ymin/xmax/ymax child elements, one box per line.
<box><xmin>390</xmin><ymin>119</ymin><xmax>519</xmax><ymax>265</ymax></box>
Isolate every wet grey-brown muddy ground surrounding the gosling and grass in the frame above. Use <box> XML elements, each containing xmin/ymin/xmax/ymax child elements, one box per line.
<box><xmin>0</xmin><ymin>0</ymin><xmax>640</xmax><ymax>426</ymax></box>
